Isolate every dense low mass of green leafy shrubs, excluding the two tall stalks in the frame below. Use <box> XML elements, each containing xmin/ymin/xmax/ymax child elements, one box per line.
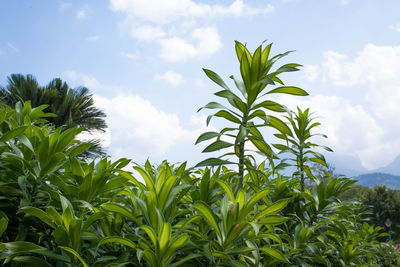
<box><xmin>0</xmin><ymin>102</ymin><xmax>380</xmax><ymax>266</ymax></box>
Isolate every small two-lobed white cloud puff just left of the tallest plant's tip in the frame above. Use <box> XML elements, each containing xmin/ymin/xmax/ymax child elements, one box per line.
<box><xmin>159</xmin><ymin>27</ymin><xmax>222</xmax><ymax>62</ymax></box>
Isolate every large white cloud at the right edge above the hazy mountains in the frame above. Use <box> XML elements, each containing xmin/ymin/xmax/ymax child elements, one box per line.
<box><xmin>298</xmin><ymin>44</ymin><xmax>400</xmax><ymax>169</ymax></box>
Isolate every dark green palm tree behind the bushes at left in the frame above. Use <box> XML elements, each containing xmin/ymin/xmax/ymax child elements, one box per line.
<box><xmin>0</xmin><ymin>74</ymin><xmax>107</xmax><ymax>156</ymax></box>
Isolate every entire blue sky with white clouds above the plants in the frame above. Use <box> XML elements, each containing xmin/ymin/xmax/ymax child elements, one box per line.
<box><xmin>0</xmin><ymin>0</ymin><xmax>400</xmax><ymax>174</ymax></box>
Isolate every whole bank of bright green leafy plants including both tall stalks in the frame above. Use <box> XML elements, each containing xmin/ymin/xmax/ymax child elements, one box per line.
<box><xmin>0</xmin><ymin>42</ymin><xmax>398</xmax><ymax>267</ymax></box>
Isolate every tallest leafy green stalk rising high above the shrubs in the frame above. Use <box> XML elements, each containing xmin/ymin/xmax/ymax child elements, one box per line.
<box><xmin>196</xmin><ymin>41</ymin><xmax>308</xmax><ymax>192</ymax></box>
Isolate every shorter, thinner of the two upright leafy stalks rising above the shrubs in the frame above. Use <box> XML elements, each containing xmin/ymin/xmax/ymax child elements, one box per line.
<box><xmin>273</xmin><ymin>108</ymin><xmax>332</xmax><ymax>191</ymax></box>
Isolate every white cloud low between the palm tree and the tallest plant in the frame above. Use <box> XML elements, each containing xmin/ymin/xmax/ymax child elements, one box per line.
<box><xmin>95</xmin><ymin>94</ymin><xmax>212</xmax><ymax>159</ymax></box>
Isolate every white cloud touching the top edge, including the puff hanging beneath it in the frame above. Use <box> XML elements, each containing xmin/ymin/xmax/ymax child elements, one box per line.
<box><xmin>110</xmin><ymin>0</ymin><xmax>274</xmax><ymax>62</ymax></box>
